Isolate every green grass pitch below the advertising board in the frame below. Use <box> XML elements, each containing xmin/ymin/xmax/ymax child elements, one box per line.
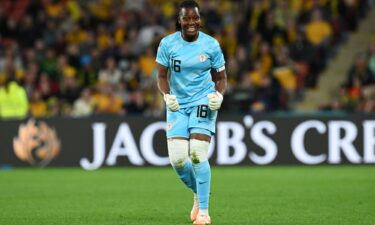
<box><xmin>0</xmin><ymin>166</ymin><xmax>375</xmax><ymax>225</ymax></box>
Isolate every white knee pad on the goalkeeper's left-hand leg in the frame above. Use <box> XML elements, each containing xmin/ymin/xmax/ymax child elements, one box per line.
<box><xmin>168</xmin><ymin>139</ymin><xmax>189</xmax><ymax>168</ymax></box>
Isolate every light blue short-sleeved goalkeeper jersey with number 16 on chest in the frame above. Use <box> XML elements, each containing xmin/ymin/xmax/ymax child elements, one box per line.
<box><xmin>156</xmin><ymin>32</ymin><xmax>225</xmax><ymax>108</ymax></box>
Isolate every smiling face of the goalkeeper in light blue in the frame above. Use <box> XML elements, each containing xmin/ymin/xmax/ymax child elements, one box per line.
<box><xmin>179</xmin><ymin>7</ymin><xmax>201</xmax><ymax>40</ymax></box>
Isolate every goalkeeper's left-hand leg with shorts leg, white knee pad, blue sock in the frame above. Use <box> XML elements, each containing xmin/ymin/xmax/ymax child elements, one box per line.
<box><xmin>167</xmin><ymin>109</ymin><xmax>197</xmax><ymax>193</ymax></box>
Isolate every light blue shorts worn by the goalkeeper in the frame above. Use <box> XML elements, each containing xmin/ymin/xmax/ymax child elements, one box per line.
<box><xmin>167</xmin><ymin>105</ymin><xmax>217</xmax><ymax>138</ymax></box>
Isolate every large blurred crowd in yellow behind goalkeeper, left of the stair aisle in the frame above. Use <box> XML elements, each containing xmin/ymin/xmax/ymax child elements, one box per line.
<box><xmin>0</xmin><ymin>0</ymin><xmax>374</xmax><ymax>118</ymax></box>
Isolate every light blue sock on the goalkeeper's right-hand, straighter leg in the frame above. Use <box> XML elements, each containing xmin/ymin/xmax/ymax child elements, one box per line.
<box><xmin>193</xmin><ymin>160</ymin><xmax>211</xmax><ymax>209</ymax></box>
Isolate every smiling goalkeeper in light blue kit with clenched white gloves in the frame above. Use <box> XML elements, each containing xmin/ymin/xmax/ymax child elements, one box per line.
<box><xmin>156</xmin><ymin>0</ymin><xmax>227</xmax><ymax>224</ymax></box>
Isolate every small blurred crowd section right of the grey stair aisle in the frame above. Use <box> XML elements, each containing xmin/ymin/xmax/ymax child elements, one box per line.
<box><xmin>321</xmin><ymin>33</ymin><xmax>375</xmax><ymax>113</ymax></box>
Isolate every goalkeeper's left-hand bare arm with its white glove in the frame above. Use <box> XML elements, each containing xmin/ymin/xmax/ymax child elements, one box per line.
<box><xmin>157</xmin><ymin>63</ymin><xmax>180</xmax><ymax>112</ymax></box>
